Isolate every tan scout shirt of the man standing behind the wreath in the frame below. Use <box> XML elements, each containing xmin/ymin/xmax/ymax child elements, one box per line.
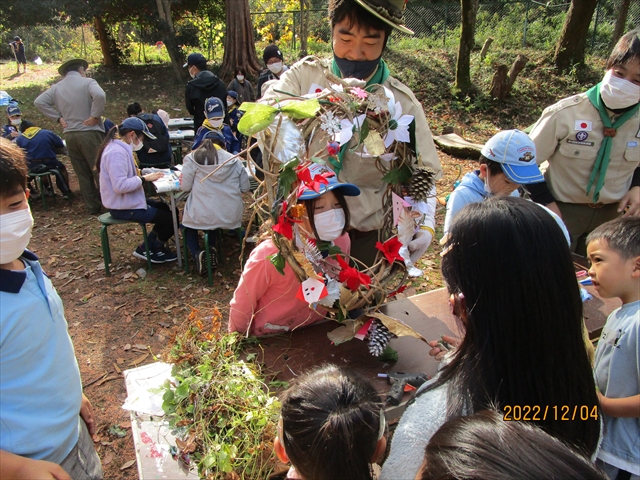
<box><xmin>260</xmin><ymin>57</ymin><xmax>442</xmax><ymax>232</ymax></box>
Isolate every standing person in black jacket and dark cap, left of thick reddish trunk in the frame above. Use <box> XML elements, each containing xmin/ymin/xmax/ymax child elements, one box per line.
<box><xmin>183</xmin><ymin>53</ymin><xmax>227</xmax><ymax>130</ymax></box>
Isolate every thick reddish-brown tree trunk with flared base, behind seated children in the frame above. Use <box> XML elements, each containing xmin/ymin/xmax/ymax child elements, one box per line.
<box><xmin>220</xmin><ymin>0</ymin><xmax>260</xmax><ymax>79</ymax></box>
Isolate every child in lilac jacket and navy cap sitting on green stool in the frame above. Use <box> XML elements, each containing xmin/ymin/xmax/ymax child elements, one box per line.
<box><xmin>96</xmin><ymin>117</ymin><xmax>178</xmax><ymax>263</ymax></box>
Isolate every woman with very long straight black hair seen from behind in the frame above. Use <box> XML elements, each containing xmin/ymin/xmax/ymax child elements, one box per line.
<box><xmin>381</xmin><ymin>197</ymin><xmax>600</xmax><ymax>479</ymax></box>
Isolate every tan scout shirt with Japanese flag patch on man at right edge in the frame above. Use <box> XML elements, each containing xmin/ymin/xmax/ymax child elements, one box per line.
<box><xmin>529</xmin><ymin>93</ymin><xmax>640</xmax><ymax>204</ymax></box>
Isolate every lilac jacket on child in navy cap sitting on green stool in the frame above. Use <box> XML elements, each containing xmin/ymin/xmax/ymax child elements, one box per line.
<box><xmin>100</xmin><ymin>140</ymin><xmax>147</xmax><ymax>210</ymax></box>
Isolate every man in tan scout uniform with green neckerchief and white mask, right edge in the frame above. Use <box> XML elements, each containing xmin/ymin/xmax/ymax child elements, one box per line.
<box><xmin>530</xmin><ymin>29</ymin><xmax>640</xmax><ymax>254</ymax></box>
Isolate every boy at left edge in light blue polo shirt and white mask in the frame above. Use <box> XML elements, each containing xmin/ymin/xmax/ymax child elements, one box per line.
<box><xmin>0</xmin><ymin>138</ymin><xmax>102</xmax><ymax>480</ymax></box>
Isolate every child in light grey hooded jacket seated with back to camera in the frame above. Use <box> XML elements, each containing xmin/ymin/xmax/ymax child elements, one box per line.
<box><xmin>180</xmin><ymin>131</ymin><xmax>249</xmax><ymax>275</ymax></box>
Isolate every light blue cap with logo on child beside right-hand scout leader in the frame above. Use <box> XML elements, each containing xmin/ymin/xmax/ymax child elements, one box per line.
<box><xmin>480</xmin><ymin>130</ymin><xmax>544</xmax><ymax>185</ymax></box>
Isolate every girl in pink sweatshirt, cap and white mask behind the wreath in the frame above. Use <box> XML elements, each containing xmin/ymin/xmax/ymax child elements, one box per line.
<box><xmin>229</xmin><ymin>163</ymin><xmax>360</xmax><ymax>336</ymax></box>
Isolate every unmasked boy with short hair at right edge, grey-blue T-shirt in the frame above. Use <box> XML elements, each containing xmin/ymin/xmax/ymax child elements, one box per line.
<box><xmin>587</xmin><ymin>217</ymin><xmax>640</xmax><ymax>479</ymax></box>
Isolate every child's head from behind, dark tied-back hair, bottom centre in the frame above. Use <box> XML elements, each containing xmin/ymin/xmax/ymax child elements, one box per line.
<box><xmin>271</xmin><ymin>365</ymin><xmax>387</xmax><ymax>480</ymax></box>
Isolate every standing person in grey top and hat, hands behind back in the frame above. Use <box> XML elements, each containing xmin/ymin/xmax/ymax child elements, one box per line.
<box><xmin>33</xmin><ymin>58</ymin><xmax>106</xmax><ymax>214</ymax></box>
